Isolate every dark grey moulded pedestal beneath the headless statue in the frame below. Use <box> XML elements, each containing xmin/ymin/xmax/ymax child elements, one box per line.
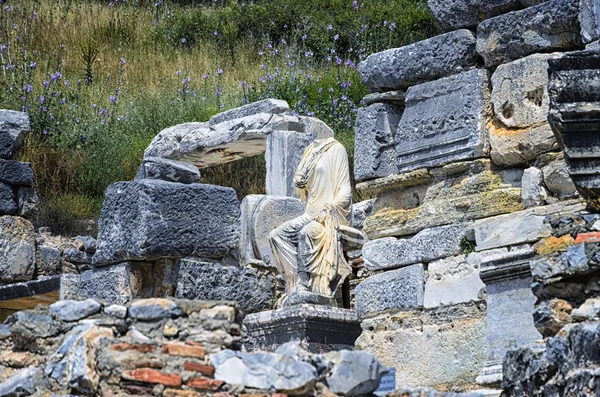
<box><xmin>244</xmin><ymin>304</ymin><xmax>361</xmax><ymax>353</ymax></box>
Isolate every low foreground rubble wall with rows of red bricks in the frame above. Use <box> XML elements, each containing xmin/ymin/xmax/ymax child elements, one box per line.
<box><xmin>0</xmin><ymin>298</ymin><xmax>388</xmax><ymax>397</ymax></box>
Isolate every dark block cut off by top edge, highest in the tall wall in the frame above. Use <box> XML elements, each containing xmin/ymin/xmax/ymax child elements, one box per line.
<box><xmin>427</xmin><ymin>0</ymin><xmax>522</xmax><ymax>31</ymax></box>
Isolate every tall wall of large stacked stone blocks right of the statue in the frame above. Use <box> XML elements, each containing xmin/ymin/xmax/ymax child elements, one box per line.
<box><xmin>353</xmin><ymin>0</ymin><xmax>599</xmax><ymax>395</ymax></box>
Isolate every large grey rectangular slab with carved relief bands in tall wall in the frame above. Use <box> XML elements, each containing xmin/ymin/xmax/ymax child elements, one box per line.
<box><xmin>395</xmin><ymin>69</ymin><xmax>491</xmax><ymax>172</ymax></box>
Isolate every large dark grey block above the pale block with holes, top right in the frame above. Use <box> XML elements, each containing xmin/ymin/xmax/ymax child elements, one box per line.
<box><xmin>477</xmin><ymin>0</ymin><xmax>581</xmax><ymax>67</ymax></box>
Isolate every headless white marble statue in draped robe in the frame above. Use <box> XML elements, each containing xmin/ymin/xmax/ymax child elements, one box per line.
<box><xmin>269</xmin><ymin>138</ymin><xmax>352</xmax><ymax>297</ymax></box>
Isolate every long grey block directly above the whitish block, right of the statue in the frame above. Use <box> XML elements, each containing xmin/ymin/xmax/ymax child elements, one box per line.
<box><xmin>363</xmin><ymin>224</ymin><xmax>470</xmax><ymax>270</ymax></box>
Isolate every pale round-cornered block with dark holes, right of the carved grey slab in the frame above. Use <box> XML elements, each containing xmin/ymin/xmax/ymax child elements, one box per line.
<box><xmin>492</xmin><ymin>54</ymin><xmax>556</xmax><ymax>128</ymax></box>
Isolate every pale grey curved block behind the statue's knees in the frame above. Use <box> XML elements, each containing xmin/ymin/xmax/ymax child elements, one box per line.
<box><xmin>240</xmin><ymin>194</ymin><xmax>305</xmax><ymax>267</ymax></box>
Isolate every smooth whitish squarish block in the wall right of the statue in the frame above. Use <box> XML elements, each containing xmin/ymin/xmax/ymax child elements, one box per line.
<box><xmin>423</xmin><ymin>252</ymin><xmax>490</xmax><ymax>309</ymax></box>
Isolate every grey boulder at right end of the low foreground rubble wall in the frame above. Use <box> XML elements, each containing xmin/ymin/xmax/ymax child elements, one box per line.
<box><xmin>324</xmin><ymin>350</ymin><xmax>388</xmax><ymax>396</ymax></box>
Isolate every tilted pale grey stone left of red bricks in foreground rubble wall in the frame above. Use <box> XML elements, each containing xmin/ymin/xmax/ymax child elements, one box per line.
<box><xmin>44</xmin><ymin>324</ymin><xmax>113</xmax><ymax>394</ymax></box>
